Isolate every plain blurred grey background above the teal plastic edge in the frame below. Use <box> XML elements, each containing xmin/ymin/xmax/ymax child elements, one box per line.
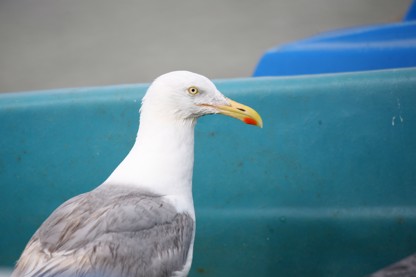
<box><xmin>0</xmin><ymin>0</ymin><xmax>411</xmax><ymax>92</ymax></box>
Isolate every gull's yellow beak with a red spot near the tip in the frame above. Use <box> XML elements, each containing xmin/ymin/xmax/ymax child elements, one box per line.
<box><xmin>213</xmin><ymin>98</ymin><xmax>263</xmax><ymax>128</ymax></box>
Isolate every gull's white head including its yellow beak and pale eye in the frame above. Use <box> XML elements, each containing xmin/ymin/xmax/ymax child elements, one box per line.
<box><xmin>141</xmin><ymin>71</ymin><xmax>263</xmax><ymax>127</ymax></box>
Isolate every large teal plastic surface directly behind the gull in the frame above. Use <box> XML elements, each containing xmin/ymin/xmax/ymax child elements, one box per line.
<box><xmin>0</xmin><ymin>69</ymin><xmax>416</xmax><ymax>277</ymax></box>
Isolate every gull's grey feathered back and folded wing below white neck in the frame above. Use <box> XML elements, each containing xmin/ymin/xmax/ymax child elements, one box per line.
<box><xmin>13</xmin><ymin>185</ymin><xmax>194</xmax><ymax>276</ymax></box>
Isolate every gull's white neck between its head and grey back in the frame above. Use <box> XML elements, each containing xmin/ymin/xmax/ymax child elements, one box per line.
<box><xmin>103</xmin><ymin>110</ymin><xmax>195</xmax><ymax>205</ymax></box>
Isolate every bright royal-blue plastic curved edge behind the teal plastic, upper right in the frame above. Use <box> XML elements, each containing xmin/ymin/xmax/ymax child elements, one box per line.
<box><xmin>254</xmin><ymin>20</ymin><xmax>416</xmax><ymax>77</ymax></box>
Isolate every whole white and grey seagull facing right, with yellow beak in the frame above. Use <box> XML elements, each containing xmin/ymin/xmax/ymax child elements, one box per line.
<box><xmin>12</xmin><ymin>71</ymin><xmax>263</xmax><ymax>277</ymax></box>
